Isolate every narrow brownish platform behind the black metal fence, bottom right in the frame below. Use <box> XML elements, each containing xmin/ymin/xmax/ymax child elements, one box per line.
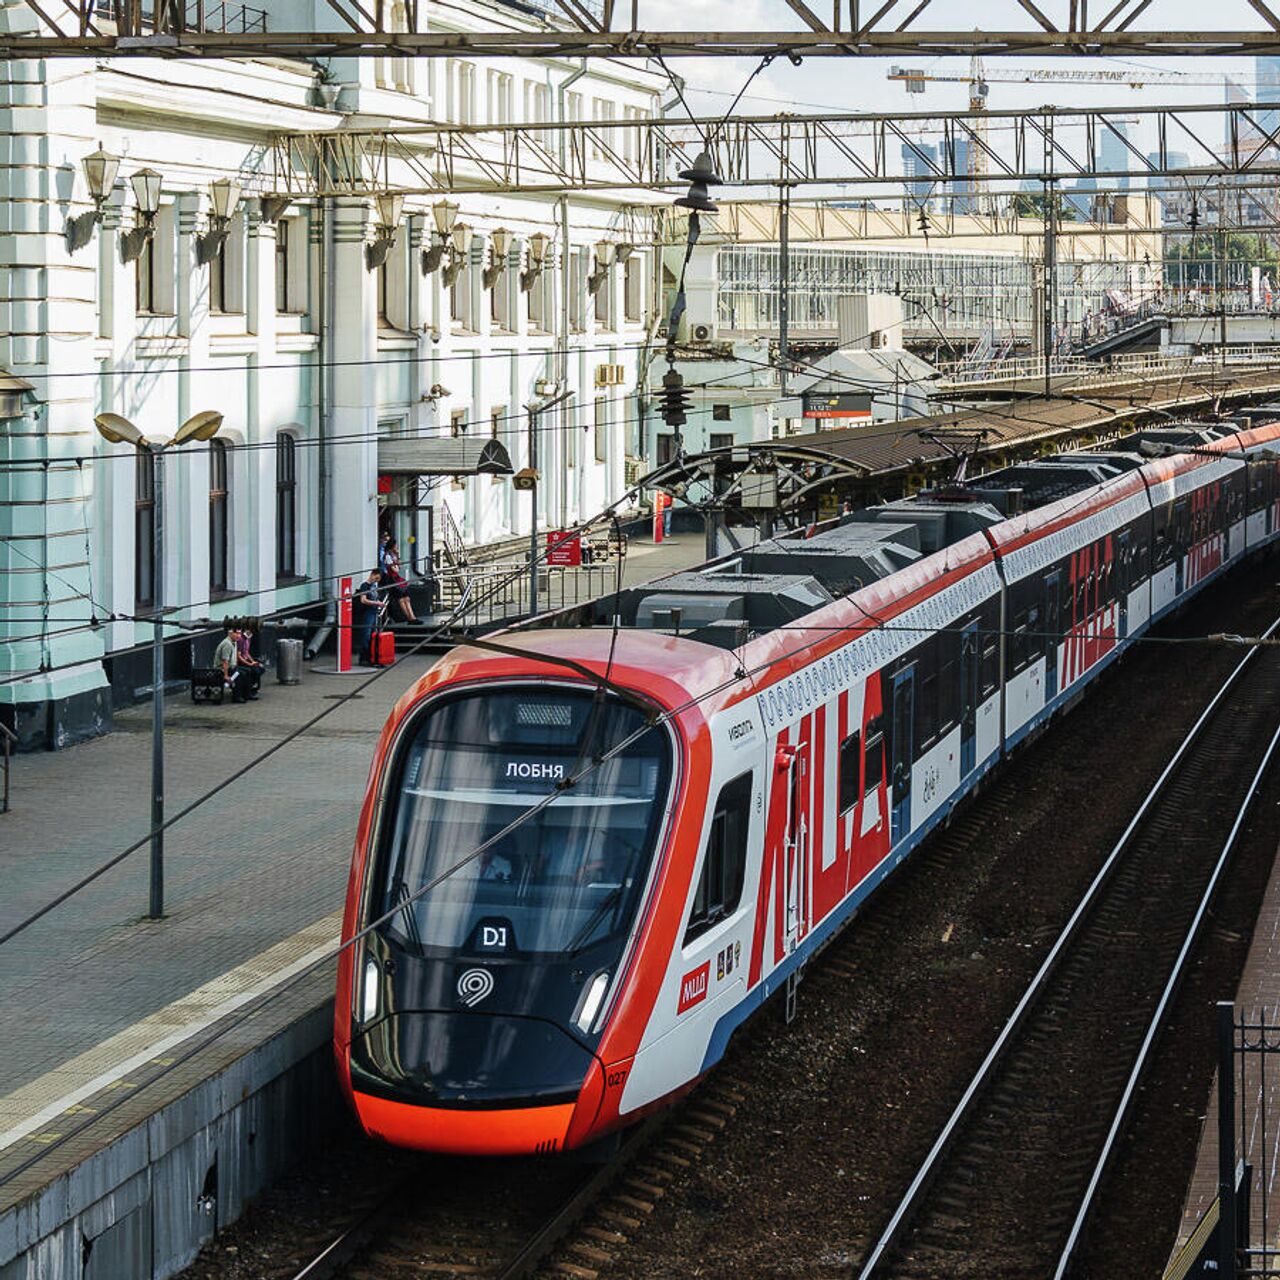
<box><xmin>1172</xmin><ymin>849</ymin><xmax>1280</xmax><ymax>1258</ymax></box>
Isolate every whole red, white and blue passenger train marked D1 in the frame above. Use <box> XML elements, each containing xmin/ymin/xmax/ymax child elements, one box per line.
<box><xmin>334</xmin><ymin>411</ymin><xmax>1280</xmax><ymax>1155</ymax></box>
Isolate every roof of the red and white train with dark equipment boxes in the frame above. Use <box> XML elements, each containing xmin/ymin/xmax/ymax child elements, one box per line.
<box><xmin>455</xmin><ymin>411</ymin><xmax>1280</xmax><ymax>711</ymax></box>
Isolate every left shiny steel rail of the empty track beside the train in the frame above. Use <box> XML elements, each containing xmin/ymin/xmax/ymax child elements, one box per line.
<box><xmin>858</xmin><ymin>617</ymin><xmax>1280</xmax><ymax>1280</ymax></box>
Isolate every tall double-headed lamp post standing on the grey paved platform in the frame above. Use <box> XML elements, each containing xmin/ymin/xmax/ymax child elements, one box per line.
<box><xmin>93</xmin><ymin>410</ymin><xmax>223</xmax><ymax>920</ymax></box>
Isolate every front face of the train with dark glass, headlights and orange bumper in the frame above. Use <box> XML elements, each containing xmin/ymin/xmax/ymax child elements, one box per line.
<box><xmin>337</xmin><ymin>680</ymin><xmax>677</xmax><ymax>1155</ymax></box>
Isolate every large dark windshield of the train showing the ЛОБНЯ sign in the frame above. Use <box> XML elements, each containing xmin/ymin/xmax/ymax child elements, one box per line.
<box><xmin>378</xmin><ymin>685</ymin><xmax>671</xmax><ymax>955</ymax></box>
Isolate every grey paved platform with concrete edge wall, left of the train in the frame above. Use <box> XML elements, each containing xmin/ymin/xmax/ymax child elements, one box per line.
<box><xmin>0</xmin><ymin>534</ymin><xmax>703</xmax><ymax>1280</ymax></box>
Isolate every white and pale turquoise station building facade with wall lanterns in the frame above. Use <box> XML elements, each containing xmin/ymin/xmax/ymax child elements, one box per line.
<box><xmin>0</xmin><ymin>0</ymin><xmax>663</xmax><ymax>740</ymax></box>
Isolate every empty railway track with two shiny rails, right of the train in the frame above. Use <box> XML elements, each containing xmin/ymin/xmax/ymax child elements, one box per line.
<box><xmin>860</xmin><ymin>618</ymin><xmax>1280</xmax><ymax>1280</ymax></box>
